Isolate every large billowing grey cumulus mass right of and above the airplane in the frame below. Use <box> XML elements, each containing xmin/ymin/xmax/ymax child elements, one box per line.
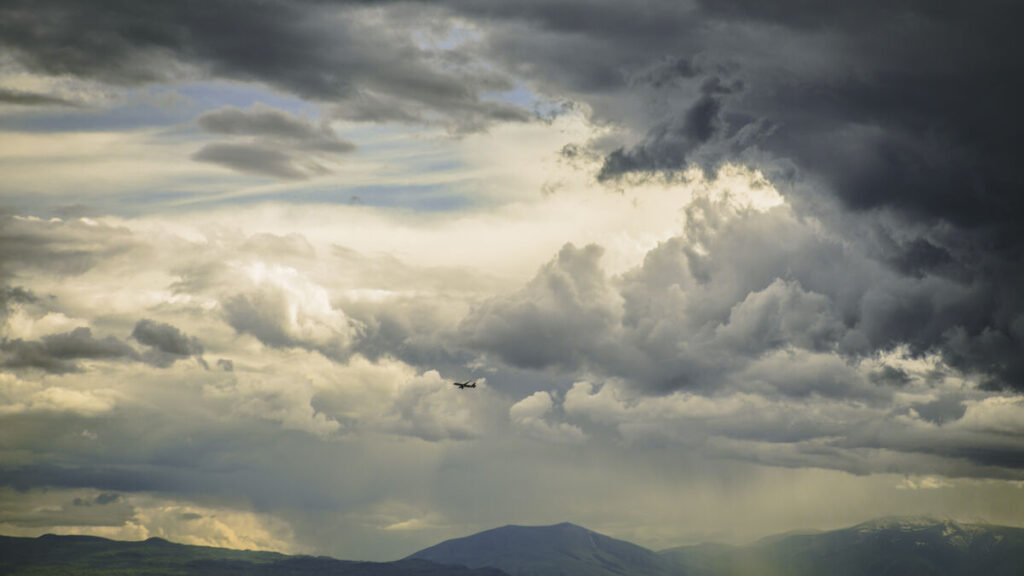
<box><xmin>461</xmin><ymin>191</ymin><xmax>1022</xmax><ymax>399</ymax></box>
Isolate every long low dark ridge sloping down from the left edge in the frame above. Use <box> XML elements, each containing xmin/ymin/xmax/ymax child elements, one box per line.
<box><xmin>0</xmin><ymin>534</ymin><xmax>507</xmax><ymax>576</ymax></box>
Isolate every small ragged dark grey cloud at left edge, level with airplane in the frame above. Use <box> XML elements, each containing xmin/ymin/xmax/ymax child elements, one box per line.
<box><xmin>0</xmin><ymin>327</ymin><xmax>138</xmax><ymax>374</ymax></box>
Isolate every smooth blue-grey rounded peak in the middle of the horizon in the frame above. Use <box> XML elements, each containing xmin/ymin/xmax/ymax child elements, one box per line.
<box><xmin>409</xmin><ymin>523</ymin><xmax>679</xmax><ymax>576</ymax></box>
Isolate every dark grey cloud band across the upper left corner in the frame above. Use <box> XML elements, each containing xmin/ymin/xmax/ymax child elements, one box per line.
<box><xmin>0</xmin><ymin>0</ymin><xmax>528</xmax><ymax>129</ymax></box>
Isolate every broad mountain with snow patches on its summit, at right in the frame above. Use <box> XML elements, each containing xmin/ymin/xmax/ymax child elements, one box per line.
<box><xmin>658</xmin><ymin>518</ymin><xmax>1024</xmax><ymax>576</ymax></box>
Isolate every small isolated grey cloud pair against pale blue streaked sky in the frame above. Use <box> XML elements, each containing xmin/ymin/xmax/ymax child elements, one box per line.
<box><xmin>193</xmin><ymin>105</ymin><xmax>355</xmax><ymax>179</ymax></box>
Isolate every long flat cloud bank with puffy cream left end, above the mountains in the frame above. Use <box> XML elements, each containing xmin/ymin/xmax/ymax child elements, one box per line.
<box><xmin>563</xmin><ymin>378</ymin><xmax>1022</xmax><ymax>478</ymax></box>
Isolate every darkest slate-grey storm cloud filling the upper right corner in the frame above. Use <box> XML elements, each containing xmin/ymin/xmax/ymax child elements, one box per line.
<box><xmin>450</xmin><ymin>1</ymin><xmax>1024</xmax><ymax>232</ymax></box>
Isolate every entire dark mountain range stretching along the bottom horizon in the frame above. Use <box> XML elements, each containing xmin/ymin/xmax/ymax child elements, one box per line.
<box><xmin>0</xmin><ymin>517</ymin><xmax>1024</xmax><ymax>576</ymax></box>
